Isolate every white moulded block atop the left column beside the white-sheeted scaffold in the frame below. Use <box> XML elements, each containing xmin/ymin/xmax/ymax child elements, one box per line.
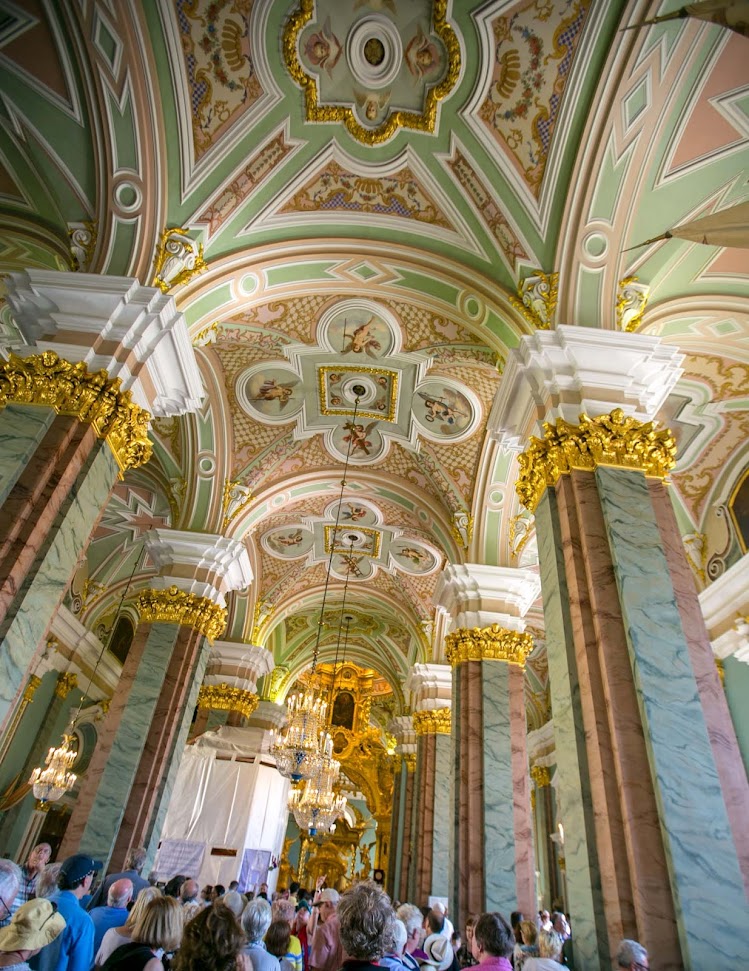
<box><xmin>145</xmin><ymin>529</ymin><xmax>252</xmax><ymax>607</ymax></box>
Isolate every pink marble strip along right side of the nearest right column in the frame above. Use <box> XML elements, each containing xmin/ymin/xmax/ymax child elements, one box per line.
<box><xmin>648</xmin><ymin>481</ymin><xmax>749</xmax><ymax>897</ymax></box>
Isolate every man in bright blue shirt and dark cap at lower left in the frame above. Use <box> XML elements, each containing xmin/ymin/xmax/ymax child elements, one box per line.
<box><xmin>37</xmin><ymin>853</ymin><xmax>102</xmax><ymax>971</ymax></box>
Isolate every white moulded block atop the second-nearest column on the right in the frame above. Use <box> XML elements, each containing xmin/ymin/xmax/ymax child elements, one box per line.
<box><xmin>434</xmin><ymin>563</ymin><xmax>541</xmax><ymax>631</ymax></box>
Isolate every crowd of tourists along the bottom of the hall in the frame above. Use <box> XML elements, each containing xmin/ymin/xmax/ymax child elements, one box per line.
<box><xmin>0</xmin><ymin>843</ymin><xmax>649</xmax><ymax>971</ymax></box>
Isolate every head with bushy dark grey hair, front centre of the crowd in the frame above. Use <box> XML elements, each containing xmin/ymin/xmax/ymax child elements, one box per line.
<box><xmin>338</xmin><ymin>881</ymin><xmax>396</xmax><ymax>962</ymax></box>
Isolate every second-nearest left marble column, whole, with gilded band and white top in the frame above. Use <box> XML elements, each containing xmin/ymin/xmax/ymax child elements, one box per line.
<box><xmin>56</xmin><ymin>529</ymin><xmax>252</xmax><ymax>868</ymax></box>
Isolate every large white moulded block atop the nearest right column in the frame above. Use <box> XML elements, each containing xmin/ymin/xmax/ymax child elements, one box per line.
<box><xmin>488</xmin><ymin>325</ymin><xmax>684</xmax><ymax>450</ymax></box>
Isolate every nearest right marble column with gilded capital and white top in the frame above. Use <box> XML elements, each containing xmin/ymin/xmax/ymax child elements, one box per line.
<box><xmin>494</xmin><ymin>327</ymin><xmax>749</xmax><ymax>971</ymax></box>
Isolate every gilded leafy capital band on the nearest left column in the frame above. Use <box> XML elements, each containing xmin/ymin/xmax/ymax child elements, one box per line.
<box><xmin>0</xmin><ymin>351</ymin><xmax>152</xmax><ymax>472</ymax></box>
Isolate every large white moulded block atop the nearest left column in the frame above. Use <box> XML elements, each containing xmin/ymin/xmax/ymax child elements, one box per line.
<box><xmin>8</xmin><ymin>269</ymin><xmax>205</xmax><ymax>418</ymax></box>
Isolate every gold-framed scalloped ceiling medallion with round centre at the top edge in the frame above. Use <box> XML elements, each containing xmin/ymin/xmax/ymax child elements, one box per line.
<box><xmin>283</xmin><ymin>0</ymin><xmax>460</xmax><ymax>145</ymax></box>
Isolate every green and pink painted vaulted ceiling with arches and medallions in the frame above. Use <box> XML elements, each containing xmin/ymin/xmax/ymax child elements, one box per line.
<box><xmin>0</xmin><ymin>0</ymin><xmax>749</xmax><ymax>718</ymax></box>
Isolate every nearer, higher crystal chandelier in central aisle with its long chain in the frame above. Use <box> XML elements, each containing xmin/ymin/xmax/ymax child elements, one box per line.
<box><xmin>270</xmin><ymin>385</ymin><xmax>366</xmax><ymax>784</ymax></box>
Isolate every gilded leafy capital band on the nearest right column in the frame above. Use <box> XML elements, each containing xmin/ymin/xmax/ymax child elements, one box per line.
<box><xmin>515</xmin><ymin>408</ymin><xmax>676</xmax><ymax>512</ymax></box>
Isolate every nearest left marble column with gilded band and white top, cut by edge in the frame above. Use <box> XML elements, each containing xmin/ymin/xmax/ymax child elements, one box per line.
<box><xmin>0</xmin><ymin>270</ymin><xmax>203</xmax><ymax>727</ymax></box>
